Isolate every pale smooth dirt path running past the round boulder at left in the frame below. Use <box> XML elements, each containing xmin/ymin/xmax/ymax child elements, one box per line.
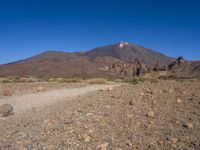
<box><xmin>0</xmin><ymin>85</ymin><xmax>118</xmax><ymax>114</ymax></box>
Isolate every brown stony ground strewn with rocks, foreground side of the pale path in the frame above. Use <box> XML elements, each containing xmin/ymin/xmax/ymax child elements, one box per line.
<box><xmin>0</xmin><ymin>80</ymin><xmax>200</xmax><ymax>150</ymax></box>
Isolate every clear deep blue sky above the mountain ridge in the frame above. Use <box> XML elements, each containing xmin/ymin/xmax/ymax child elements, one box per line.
<box><xmin>0</xmin><ymin>0</ymin><xmax>200</xmax><ymax>64</ymax></box>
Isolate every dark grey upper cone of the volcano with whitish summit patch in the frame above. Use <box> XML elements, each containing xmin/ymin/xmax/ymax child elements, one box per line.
<box><xmin>85</xmin><ymin>42</ymin><xmax>172</xmax><ymax>65</ymax></box>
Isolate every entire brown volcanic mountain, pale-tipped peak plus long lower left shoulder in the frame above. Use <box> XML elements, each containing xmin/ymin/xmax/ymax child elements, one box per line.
<box><xmin>0</xmin><ymin>42</ymin><xmax>174</xmax><ymax>77</ymax></box>
